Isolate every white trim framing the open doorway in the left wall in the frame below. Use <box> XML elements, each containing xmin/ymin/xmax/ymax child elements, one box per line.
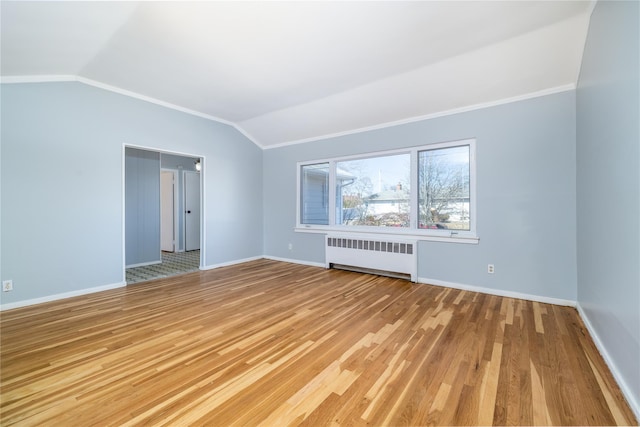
<box><xmin>120</xmin><ymin>142</ymin><xmax>207</xmax><ymax>284</ymax></box>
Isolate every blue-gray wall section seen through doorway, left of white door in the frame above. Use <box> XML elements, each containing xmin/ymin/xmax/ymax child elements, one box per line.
<box><xmin>124</xmin><ymin>148</ymin><xmax>162</xmax><ymax>266</ymax></box>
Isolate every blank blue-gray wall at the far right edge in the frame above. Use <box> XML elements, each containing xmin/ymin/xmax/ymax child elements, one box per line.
<box><xmin>576</xmin><ymin>1</ymin><xmax>640</xmax><ymax>414</ymax></box>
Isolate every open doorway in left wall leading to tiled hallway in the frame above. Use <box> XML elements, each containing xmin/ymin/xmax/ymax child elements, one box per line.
<box><xmin>123</xmin><ymin>146</ymin><xmax>204</xmax><ymax>284</ymax></box>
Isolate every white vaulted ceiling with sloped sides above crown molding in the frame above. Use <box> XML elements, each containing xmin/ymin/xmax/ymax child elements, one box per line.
<box><xmin>0</xmin><ymin>1</ymin><xmax>594</xmax><ymax>148</ymax></box>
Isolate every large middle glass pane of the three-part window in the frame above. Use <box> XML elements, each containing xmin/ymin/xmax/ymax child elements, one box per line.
<box><xmin>336</xmin><ymin>154</ymin><xmax>411</xmax><ymax>227</ymax></box>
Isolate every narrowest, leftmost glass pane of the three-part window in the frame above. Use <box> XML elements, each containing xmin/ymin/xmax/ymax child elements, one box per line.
<box><xmin>300</xmin><ymin>163</ymin><xmax>329</xmax><ymax>225</ymax></box>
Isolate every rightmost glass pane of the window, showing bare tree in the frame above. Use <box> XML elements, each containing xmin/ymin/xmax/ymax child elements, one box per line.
<box><xmin>418</xmin><ymin>145</ymin><xmax>470</xmax><ymax>230</ymax></box>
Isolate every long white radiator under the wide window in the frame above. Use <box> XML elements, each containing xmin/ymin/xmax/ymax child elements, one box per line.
<box><xmin>325</xmin><ymin>235</ymin><xmax>418</xmax><ymax>282</ymax></box>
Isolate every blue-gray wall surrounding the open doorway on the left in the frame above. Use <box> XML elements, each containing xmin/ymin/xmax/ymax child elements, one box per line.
<box><xmin>0</xmin><ymin>82</ymin><xmax>263</xmax><ymax>305</ymax></box>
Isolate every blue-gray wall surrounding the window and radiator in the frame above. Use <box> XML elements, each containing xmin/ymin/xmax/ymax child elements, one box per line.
<box><xmin>263</xmin><ymin>91</ymin><xmax>576</xmax><ymax>301</ymax></box>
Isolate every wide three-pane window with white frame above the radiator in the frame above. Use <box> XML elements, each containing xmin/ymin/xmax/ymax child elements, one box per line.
<box><xmin>297</xmin><ymin>140</ymin><xmax>477</xmax><ymax>243</ymax></box>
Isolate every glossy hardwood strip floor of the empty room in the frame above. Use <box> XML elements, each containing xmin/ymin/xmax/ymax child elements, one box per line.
<box><xmin>0</xmin><ymin>260</ymin><xmax>637</xmax><ymax>426</ymax></box>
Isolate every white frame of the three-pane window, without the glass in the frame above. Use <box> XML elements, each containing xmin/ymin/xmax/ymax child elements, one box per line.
<box><xmin>295</xmin><ymin>138</ymin><xmax>480</xmax><ymax>244</ymax></box>
